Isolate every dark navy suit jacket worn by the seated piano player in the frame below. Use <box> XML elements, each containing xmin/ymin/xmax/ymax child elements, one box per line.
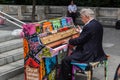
<box><xmin>69</xmin><ymin>19</ymin><xmax>106</xmax><ymax>62</ymax></box>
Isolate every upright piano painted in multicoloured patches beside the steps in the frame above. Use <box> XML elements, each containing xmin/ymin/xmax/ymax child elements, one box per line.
<box><xmin>23</xmin><ymin>18</ymin><xmax>79</xmax><ymax>80</ymax></box>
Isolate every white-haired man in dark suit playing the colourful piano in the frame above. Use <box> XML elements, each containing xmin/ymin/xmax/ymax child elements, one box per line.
<box><xmin>60</xmin><ymin>9</ymin><xmax>106</xmax><ymax>80</ymax></box>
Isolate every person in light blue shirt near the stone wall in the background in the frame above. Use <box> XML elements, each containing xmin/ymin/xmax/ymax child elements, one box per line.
<box><xmin>68</xmin><ymin>0</ymin><xmax>77</xmax><ymax>24</ymax></box>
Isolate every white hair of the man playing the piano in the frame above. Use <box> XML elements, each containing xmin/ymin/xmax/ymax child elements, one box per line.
<box><xmin>80</xmin><ymin>8</ymin><xmax>95</xmax><ymax>18</ymax></box>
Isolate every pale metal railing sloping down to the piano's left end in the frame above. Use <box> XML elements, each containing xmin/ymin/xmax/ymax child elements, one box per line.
<box><xmin>0</xmin><ymin>11</ymin><xmax>25</xmax><ymax>28</ymax></box>
